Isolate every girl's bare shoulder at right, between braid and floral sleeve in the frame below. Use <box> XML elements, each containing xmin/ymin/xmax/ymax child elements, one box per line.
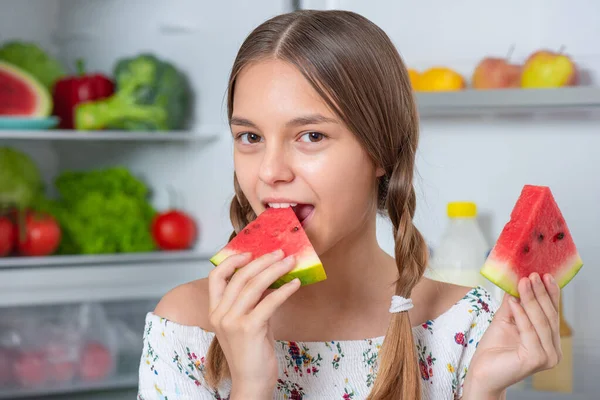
<box><xmin>413</xmin><ymin>278</ymin><xmax>473</xmax><ymax>320</ymax></box>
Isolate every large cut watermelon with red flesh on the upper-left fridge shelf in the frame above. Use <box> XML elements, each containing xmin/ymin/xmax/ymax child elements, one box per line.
<box><xmin>0</xmin><ymin>61</ymin><xmax>52</xmax><ymax>118</ymax></box>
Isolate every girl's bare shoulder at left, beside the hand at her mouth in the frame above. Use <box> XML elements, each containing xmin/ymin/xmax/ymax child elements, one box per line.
<box><xmin>154</xmin><ymin>278</ymin><xmax>211</xmax><ymax>331</ymax></box>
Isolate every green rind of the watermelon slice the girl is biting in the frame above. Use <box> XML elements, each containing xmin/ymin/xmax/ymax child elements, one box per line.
<box><xmin>210</xmin><ymin>248</ymin><xmax>327</xmax><ymax>289</ymax></box>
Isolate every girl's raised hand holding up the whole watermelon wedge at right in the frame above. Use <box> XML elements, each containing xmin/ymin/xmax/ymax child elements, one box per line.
<box><xmin>463</xmin><ymin>273</ymin><xmax>562</xmax><ymax>400</ymax></box>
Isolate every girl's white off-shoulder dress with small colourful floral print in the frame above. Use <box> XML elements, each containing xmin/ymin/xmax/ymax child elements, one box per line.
<box><xmin>138</xmin><ymin>287</ymin><xmax>497</xmax><ymax>400</ymax></box>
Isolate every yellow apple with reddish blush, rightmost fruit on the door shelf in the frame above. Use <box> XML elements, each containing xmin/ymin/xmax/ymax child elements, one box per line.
<box><xmin>521</xmin><ymin>49</ymin><xmax>579</xmax><ymax>89</ymax></box>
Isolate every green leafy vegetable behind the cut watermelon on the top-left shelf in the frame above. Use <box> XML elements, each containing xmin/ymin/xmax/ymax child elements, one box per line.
<box><xmin>0</xmin><ymin>40</ymin><xmax>67</xmax><ymax>93</ymax></box>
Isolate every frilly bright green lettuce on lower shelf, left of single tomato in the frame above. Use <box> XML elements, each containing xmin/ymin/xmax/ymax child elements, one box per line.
<box><xmin>36</xmin><ymin>167</ymin><xmax>156</xmax><ymax>254</ymax></box>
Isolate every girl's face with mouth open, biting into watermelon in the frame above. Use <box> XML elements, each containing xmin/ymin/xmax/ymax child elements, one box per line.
<box><xmin>230</xmin><ymin>60</ymin><xmax>380</xmax><ymax>254</ymax></box>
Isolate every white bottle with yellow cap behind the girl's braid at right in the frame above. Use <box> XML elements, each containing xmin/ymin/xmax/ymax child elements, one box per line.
<box><xmin>426</xmin><ymin>201</ymin><xmax>501</xmax><ymax>301</ymax></box>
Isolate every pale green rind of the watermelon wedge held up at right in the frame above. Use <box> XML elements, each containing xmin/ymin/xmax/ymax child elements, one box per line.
<box><xmin>480</xmin><ymin>252</ymin><xmax>583</xmax><ymax>297</ymax></box>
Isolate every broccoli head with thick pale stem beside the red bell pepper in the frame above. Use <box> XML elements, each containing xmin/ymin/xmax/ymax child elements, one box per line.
<box><xmin>75</xmin><ymin>54</ymin><xmax>191</xmax><ymax>131</ymax></box>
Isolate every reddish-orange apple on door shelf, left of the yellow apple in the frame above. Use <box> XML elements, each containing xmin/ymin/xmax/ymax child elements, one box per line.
<box><xmin>471</xmin><ymin>57</ymin><xmax>522</xmax><ymax>89</ymax></box>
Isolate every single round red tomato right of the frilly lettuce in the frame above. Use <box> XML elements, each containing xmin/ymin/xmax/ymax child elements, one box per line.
<box><xmin>152</xmin><ymin>210</ymin><xmax>197</xmax><ymax>250</ymax></box>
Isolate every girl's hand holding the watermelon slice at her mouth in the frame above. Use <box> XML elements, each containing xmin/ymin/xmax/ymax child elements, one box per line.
<box><xmin>208</xmin><ymin>250</ymin><xmax>300</xmax><ymax>400</ymax></box>
